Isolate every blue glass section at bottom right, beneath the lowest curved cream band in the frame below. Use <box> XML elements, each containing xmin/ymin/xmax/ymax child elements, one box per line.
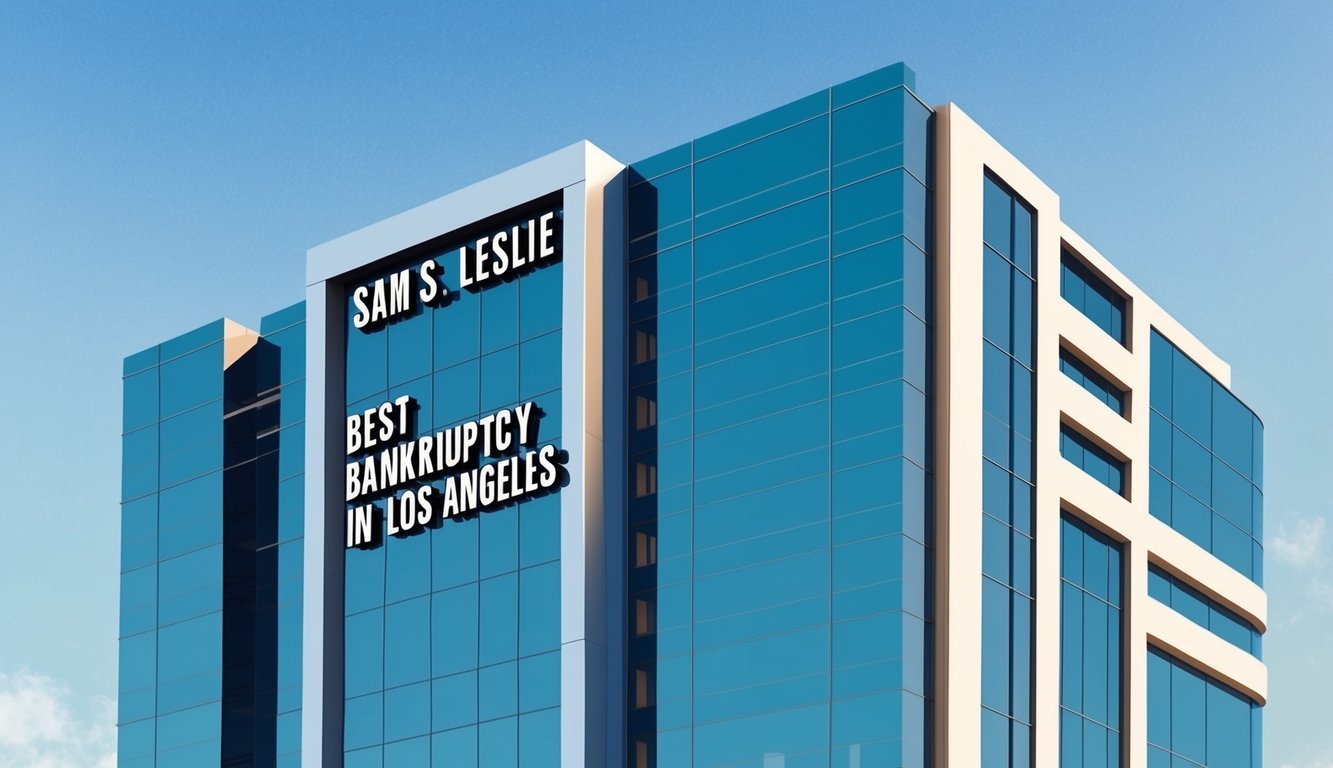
<box><xmin>1148</xmin><ymin>647</ymin><xmax>1264</xmax><ymax>768</ymax></box>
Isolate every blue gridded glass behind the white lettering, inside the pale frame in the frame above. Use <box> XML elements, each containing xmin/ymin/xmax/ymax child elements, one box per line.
<box><xmin>343</xmin><ymin>208</ymin><xmax>564</xmax><ymax>768</ymax></box>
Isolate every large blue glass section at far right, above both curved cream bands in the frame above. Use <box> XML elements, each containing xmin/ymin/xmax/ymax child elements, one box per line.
<box><xmin>1148</xmin><ymin>329</ymin><xmax>1264</xmax><ymax>584</ymax></box>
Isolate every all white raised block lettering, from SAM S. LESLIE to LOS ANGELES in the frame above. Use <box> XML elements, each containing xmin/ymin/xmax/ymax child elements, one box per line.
<box><xmin>344</xmin><ymin>211</ymin><xmax>565</xmax><ymax>548</ymax></box>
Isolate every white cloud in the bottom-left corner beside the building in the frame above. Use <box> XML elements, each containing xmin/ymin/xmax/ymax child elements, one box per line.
<box><xmin>0</xmin><ymin>671</ymin><xmax>116</xmax><ymax>768</ymax></box>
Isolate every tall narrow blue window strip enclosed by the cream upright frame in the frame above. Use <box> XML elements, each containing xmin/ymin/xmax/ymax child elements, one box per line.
<box><xmin>981</xmin><ymin>176</ymin><xmax>1037</xmax><ymax>768</ymax></box>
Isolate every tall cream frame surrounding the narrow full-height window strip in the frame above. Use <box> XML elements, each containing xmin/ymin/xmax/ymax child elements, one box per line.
<box><xmin>934</xmin><ymin>104</ymin><xmax>1060</xmax><ymax>767</ymax></box>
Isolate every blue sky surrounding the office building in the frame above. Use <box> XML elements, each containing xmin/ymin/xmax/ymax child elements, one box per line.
<box><xmin>0</xmin><ymin>0</ymin><xmax>1333</xmax><ymax>768</ymax></box>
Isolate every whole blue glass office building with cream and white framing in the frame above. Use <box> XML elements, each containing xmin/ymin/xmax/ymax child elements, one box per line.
<box><xmin>120</xmin><ymin>64</ymin><xmax>1266</xmax><ymax>768</ymax></box>
